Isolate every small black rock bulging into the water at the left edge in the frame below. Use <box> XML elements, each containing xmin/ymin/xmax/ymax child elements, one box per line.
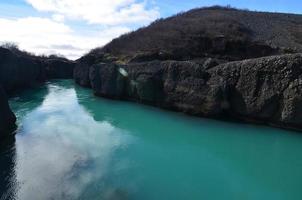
<box><xmin>0</xmin><ymin>85</ymin><xmax>16</xmax><ymax>141</ymax></box>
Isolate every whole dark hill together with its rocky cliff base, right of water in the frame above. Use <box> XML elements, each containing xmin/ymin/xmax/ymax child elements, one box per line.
<box><xmin>74</xmin><ymin>7</ymin><xmax>302</xmax><ymax>130</ymax></box>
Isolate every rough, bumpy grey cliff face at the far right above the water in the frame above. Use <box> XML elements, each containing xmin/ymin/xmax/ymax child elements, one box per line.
<box><xmin>210</xmin><ymin>54</ymin><xmax>302</xmax><ymax>128</ymax></box>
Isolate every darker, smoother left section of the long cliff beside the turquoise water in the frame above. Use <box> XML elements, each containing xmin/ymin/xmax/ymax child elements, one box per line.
<box><xmin>83</xmin><ymin>60</ymin><xmax>223</xmax><ymax>115</ymax></box>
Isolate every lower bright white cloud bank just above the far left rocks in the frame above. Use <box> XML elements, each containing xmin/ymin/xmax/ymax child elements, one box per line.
<box><xmin>0</xmin><ymin>17</ymin><xmax>130</xmax><ymax>59</ymax></box>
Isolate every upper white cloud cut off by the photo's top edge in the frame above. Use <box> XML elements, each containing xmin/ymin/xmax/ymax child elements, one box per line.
<box><xmin>26</xmin><ymin>0</ymin><xmax>159</xmax><ymax>25</ymax></box>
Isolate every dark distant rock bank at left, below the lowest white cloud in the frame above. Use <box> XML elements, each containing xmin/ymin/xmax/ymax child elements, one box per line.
<box><xmin>0</xmin><ymin>47</ymin><xmax>75</xmax><ymax>92</ymax></box>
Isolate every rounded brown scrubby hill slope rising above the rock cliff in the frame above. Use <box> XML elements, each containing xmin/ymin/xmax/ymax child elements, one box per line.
<box><xmin>92</xmin><ymin>7</ymin><xmax>302</xmax><ymax>61</ymax></box>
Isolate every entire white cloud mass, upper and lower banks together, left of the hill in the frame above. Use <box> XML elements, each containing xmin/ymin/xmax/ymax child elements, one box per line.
<box><xmin>0</xmin><ymin>0</ymin><xmax>159</xmax><ymax>59</ymax></box>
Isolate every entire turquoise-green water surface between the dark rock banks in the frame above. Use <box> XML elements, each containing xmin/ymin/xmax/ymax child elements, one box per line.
<box><xmin>0</xmin><ymin>80</ymin><xmax>302</xmax><ymax>200</ymax></box>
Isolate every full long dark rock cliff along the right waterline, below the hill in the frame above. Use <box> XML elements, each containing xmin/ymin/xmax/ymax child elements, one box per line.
<box><xmin>74</xmin><ymin>54</ymin><xmax>302</xmax><ymax>130</ymax></box>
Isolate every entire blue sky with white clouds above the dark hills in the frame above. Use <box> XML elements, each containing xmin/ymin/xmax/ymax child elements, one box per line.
<box><xmin>0</xmin><ymin>0</ymin><xmax>302</xmax><ymax>59</ymax></box>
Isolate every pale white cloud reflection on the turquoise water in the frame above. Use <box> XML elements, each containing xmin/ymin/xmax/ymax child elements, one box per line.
<box><xmin>1</xmin><ymin>81</ymin><xmax>130</xmax><ymax>200</ymax></box>
